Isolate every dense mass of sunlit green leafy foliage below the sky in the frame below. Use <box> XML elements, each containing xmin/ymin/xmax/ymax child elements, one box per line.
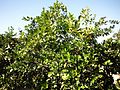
<box><xmin>0</xmin><ymin>1</ymin><xmax>120</xmax><ymax>90</ymax></box>
